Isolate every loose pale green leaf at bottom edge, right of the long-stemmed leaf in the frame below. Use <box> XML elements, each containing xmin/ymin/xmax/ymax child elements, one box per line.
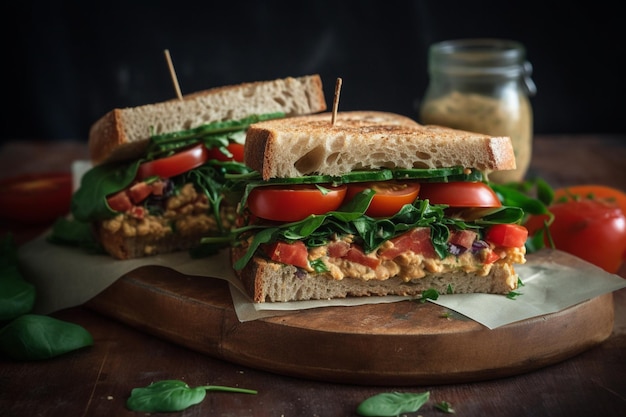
<box><xmin>356</xmin><ymin>391</ymin><xmax>430</xmax><ymax>417</ymax></box>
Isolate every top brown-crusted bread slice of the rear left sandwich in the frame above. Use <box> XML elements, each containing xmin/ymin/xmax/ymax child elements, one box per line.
<box><xmin>89</xmin><ymin>75</ymin><xmax>326</xmax><ymax>164</ymax></box>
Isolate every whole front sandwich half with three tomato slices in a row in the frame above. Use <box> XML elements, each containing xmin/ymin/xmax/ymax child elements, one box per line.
<box><xmin>224</xmin><ymin>112</ymin><xmax>527</xmax><ymax>303</ymax></box>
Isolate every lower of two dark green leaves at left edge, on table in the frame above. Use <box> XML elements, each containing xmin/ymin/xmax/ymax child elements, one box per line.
<box><xmin>0</xmin><ymin>314</ymin><xmax>93</xmax><ymax>361</ymax></box>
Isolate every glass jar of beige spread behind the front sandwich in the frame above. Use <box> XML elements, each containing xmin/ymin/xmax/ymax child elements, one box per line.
<box><xmin>419</xmin><ymin>39</ymin><xmax>536</xmax><ymax>183</ymax></box>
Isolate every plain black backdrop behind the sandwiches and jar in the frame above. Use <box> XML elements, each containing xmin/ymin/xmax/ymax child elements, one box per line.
<box><xmin>1</xmin><ymin>0</ymin><xmax>626</xmax><ymax>140</ymax></box>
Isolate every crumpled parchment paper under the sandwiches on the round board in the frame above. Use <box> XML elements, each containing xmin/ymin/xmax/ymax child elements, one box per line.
<box><xmin>19</xmin><ymin>234</ymin><xmax>626</xmax><ymax>329</ymax></box>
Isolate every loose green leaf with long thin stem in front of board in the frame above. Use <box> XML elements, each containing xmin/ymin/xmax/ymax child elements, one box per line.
<box><xmin>126</xmin><ymin>380</ymin><xmax>257</xmax><ymax>413</ymax></box>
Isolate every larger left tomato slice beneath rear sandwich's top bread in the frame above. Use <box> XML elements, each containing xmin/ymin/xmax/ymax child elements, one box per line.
<box><xmin>136</xmin><ymin>143</ymin><xmax>209</xmax><ymax>181</ymax></box>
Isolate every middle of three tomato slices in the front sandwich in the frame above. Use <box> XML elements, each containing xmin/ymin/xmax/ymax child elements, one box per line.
<box><xmin>346</xmin><ymin>181</ymin><xmax>420</xmax><ymax>217</ymax></box>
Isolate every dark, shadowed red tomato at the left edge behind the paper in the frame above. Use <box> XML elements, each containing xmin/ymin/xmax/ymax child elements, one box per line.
<box><xmin>0</xmin><ymin>172</ymin><xmax>72</xmax><ymax>224</ymax></box>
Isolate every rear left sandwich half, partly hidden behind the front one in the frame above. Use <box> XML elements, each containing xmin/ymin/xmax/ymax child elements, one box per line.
<box><xmin>72</xmin><ymin>75</ymin><xmax>326</xmax><ymax>259</ymax></box>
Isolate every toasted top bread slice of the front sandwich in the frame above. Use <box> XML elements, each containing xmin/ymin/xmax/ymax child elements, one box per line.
<box><xmin>244</xmin><ymin>112</ymin><xmax>515</xmax><ymax>180</ymax></box>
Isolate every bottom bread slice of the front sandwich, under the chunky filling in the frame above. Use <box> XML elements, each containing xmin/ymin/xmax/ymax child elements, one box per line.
<box><xmin>231</xmin><ymin>247</ymin><xmax>517</xmax><ymax>303</ymax></box>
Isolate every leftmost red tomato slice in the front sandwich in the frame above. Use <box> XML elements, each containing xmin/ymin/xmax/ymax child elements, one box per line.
<box><xmin>248</xmin><ymin>184</ymin><xmax>347</xmax><ymax>222</ymax></box>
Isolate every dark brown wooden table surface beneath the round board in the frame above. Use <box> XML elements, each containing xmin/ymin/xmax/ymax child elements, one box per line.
<box><xmin>0</xmin><ymin>135</ymin><xmax>626</xmax><ymax>417</ymax></box>
